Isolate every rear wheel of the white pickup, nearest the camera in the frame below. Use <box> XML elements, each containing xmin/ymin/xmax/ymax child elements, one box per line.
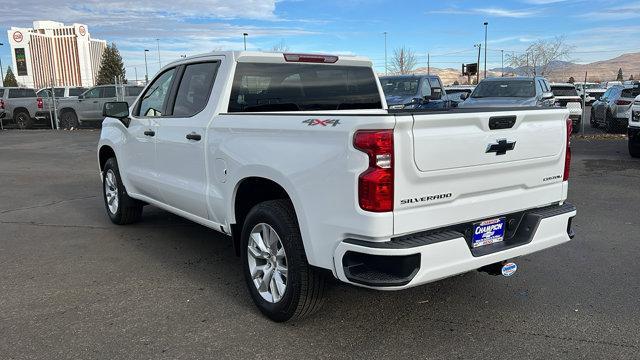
<box><xmin>242</xmin><ymin>200</ymin><xmax>325</xmax><ymax>322</ymax></box>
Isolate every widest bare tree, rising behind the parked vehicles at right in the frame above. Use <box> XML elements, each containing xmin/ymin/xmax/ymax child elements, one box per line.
<box><xmin>508</xmin><ymin>37</ymin><xmax>573</xmax><ymax>76</ymax></box>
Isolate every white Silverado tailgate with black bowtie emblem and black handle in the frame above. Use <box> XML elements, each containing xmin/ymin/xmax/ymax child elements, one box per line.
<box><xmin>394</xmin><ymin>109</ymin><xmax>568</xmax><ymax>234</ymax></box>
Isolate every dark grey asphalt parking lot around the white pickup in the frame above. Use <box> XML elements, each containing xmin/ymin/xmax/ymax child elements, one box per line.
<box><xmin>0</xmin><ymin>125</ymin><xmax>640</xmax><ymax>359</ymax></box>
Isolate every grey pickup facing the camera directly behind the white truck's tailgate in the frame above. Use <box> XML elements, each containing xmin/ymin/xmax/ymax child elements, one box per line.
<box><xmin>458</xmin><ymin>76</ymin><xmax>555</xmax><ymax>108</ymax></box>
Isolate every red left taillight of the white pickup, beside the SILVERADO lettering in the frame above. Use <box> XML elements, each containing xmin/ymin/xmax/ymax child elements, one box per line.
<box><xmin>353</xmin><ymin>130</ymin><xmax>393</xmax><ymax>212</ymax></box>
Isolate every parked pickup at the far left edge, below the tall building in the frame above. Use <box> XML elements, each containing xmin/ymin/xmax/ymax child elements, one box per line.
<box><xmin>0</xmin><ymin>87</ymin><xmax>46</xmax><ymax>129</ymax></box>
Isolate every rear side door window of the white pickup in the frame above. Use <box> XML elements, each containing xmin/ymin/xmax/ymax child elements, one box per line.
<box><xmin>172</xmin><ymin>62</ymin><xmax>219</xmax><ymax>117</ymax></box>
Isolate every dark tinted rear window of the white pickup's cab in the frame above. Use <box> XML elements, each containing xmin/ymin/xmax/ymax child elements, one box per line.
<box><xmin>229</xmin><ymin>63</ymin><xmax>382</xmax><ymax>112</ymax></box>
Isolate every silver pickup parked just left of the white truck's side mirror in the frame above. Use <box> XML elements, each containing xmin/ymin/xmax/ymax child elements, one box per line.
<box><xmin>57</xmin><ymin>85</ymin><xmax>143</xmax><ymax>129</ymax></box>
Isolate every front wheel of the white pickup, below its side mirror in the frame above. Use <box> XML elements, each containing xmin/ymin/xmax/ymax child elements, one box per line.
<box><xmin>102</xmin><ymin>158</ymin><xmax>144</xmax><ymax>225</ymax></box>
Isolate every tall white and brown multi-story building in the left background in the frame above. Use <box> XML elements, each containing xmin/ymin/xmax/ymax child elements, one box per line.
<box><xmin>7</xmin><ymin>21</ymin><xmax>107</xmax><ymax>88</ymax></box>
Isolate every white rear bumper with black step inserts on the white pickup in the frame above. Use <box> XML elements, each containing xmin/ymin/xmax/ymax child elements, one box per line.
<box><xmin>334</xmin><ymin>203</ymin><xmax>576</xmax><ymax>290</ymax></box>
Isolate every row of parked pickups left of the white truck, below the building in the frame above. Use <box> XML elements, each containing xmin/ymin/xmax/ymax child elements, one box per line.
<box><xmin>0</xmin><ymin>85</ymin><xmax>143</xmax><ymax>129</ymax></box>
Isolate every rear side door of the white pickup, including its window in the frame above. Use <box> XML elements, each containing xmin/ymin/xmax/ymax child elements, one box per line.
<box><xmin>156</xmin><ymin>60</ymin><xmax>220</xmax><ymax>219</ymax></box>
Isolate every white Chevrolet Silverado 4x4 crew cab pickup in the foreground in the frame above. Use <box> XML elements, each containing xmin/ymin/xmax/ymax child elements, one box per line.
<box><xmin>98</xmin><ymin>51</ymin><xmax>576</xmax><ymax>321</ymax></box>
